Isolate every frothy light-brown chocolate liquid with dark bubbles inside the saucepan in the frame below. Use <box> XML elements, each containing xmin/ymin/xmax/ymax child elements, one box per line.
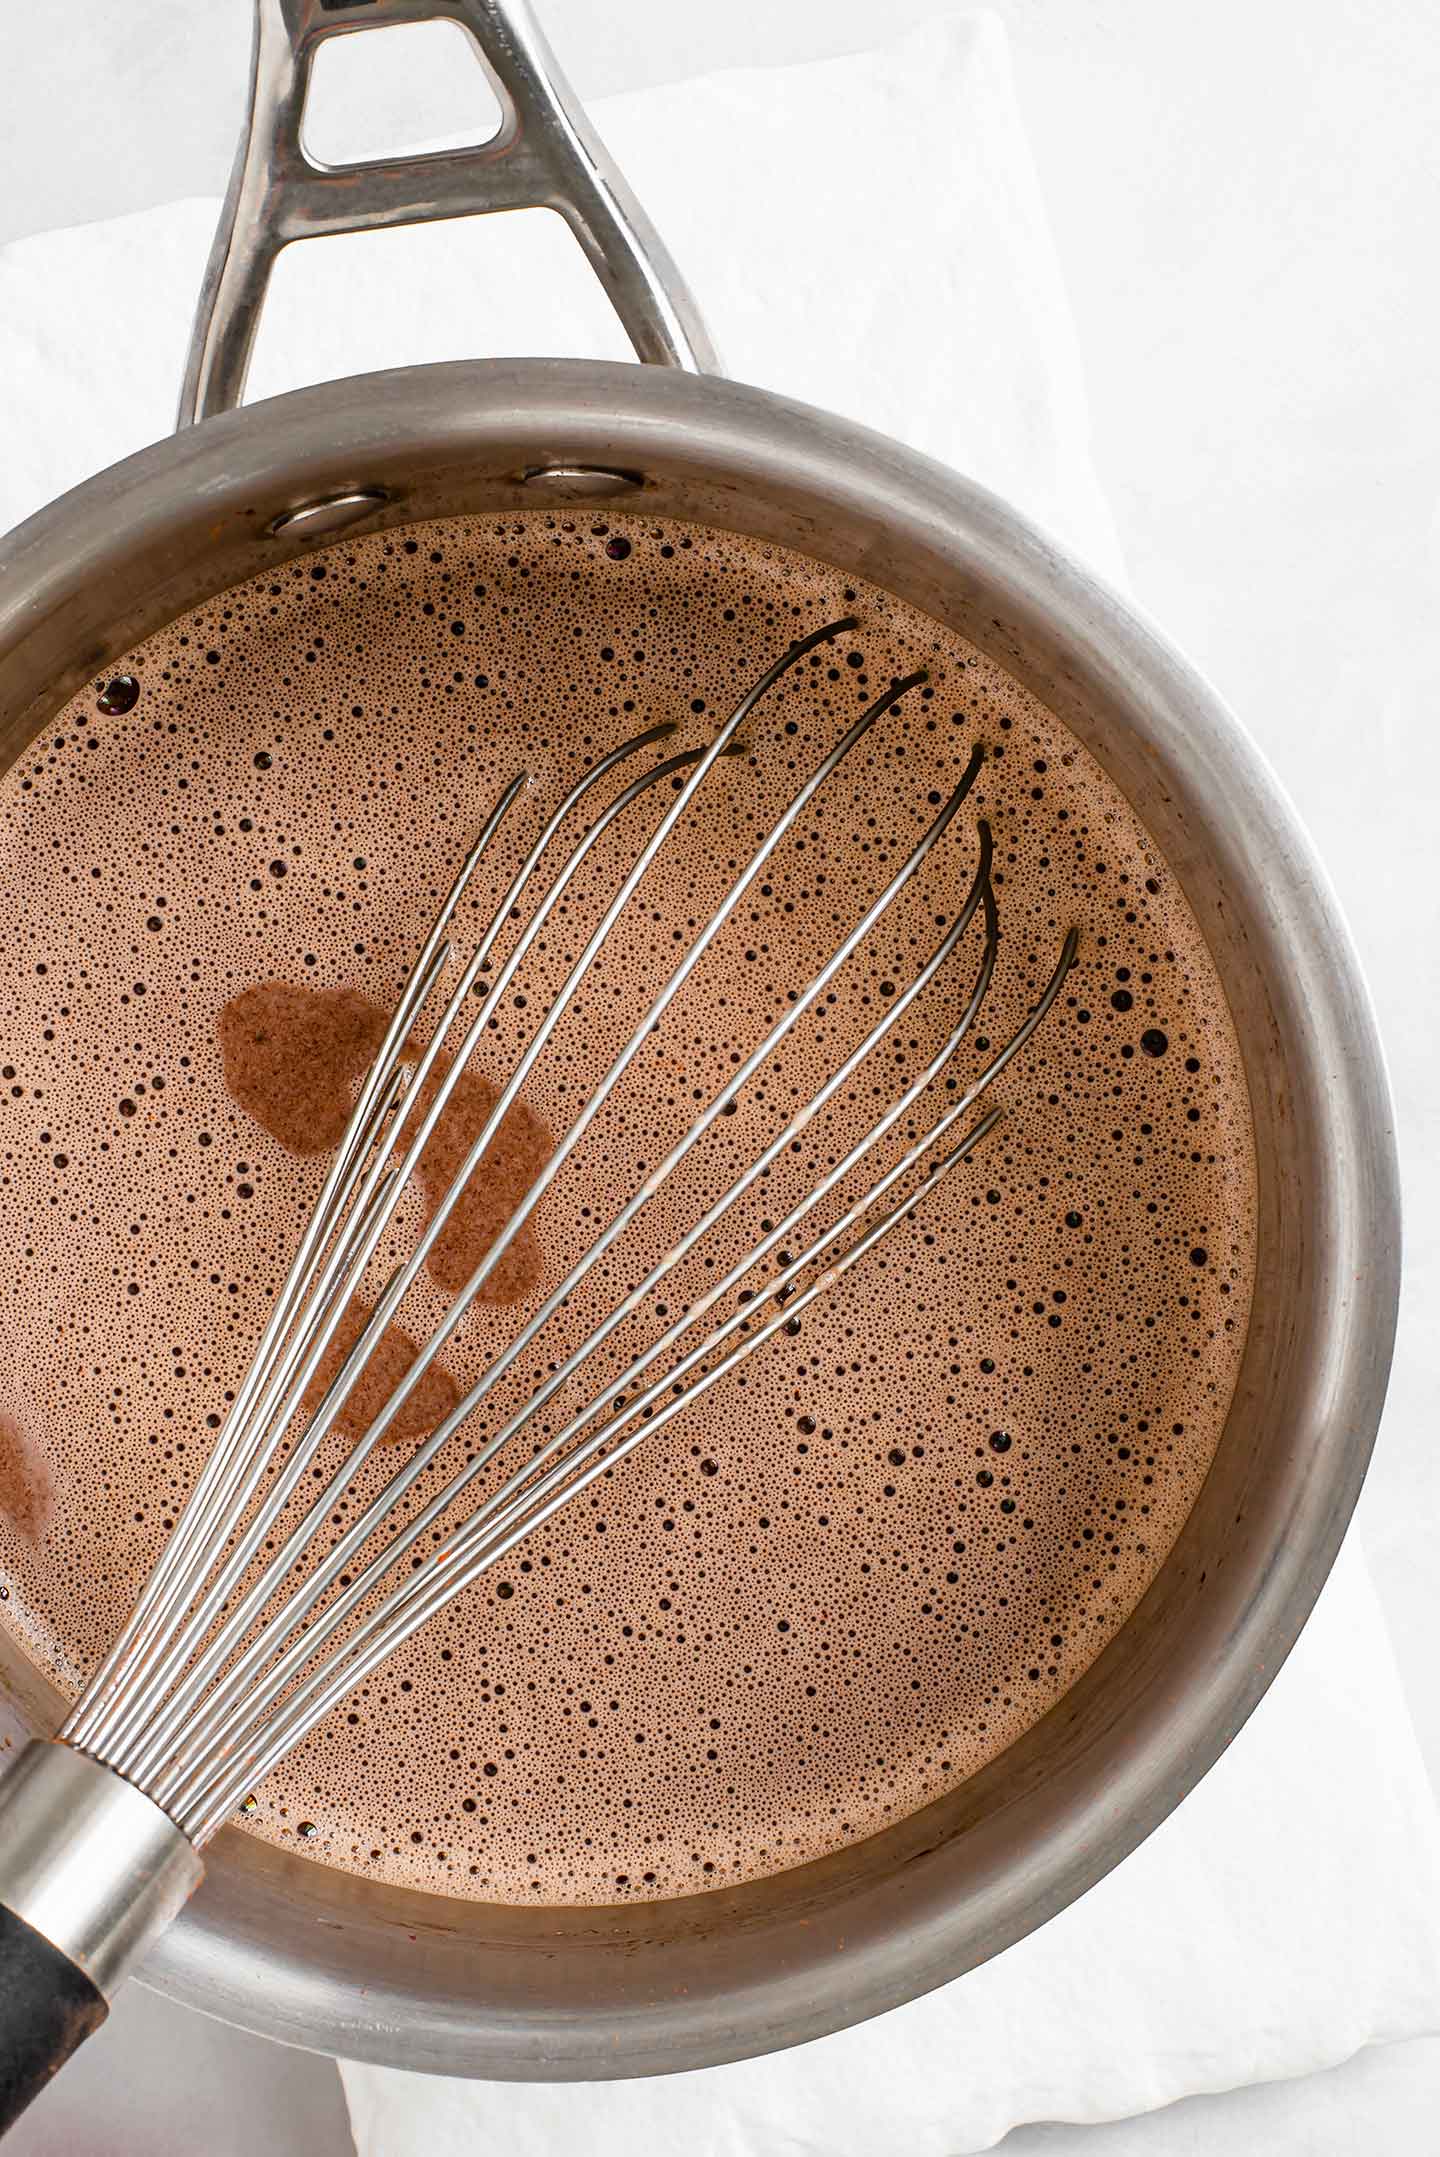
<box><xmin>0</xmin><ymin>516</ymin><xmax>1252</xmax><ymax>1902</ymax></box>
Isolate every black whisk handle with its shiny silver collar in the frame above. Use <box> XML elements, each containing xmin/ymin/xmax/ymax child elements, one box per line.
<box><xmin>0</xmin><ymin>1743</ymin><xmax>205</xmax><ymax>2133</ymax></box>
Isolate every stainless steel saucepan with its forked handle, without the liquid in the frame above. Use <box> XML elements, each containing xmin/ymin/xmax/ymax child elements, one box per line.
<box><xmin>0</xmin><ymin>0</ymin><xmax>1399</xmax><ymax>2079</ymax></box>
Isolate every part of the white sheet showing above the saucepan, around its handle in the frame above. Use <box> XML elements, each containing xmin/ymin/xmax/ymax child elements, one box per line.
<box><xmin>0</xmin><ymin>15</ymin><xmax>1119</xmax><ymax>576</ymax></box>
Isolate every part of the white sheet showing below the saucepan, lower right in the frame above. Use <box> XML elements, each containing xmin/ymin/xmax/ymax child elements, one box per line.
<box><xmin>341</xmin><ymin>1544</ymin><xmax>1440</xmax><ymax>2157</ymax></box>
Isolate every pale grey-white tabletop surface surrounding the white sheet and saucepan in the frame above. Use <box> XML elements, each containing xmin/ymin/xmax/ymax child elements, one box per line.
<box><xmin>0</xmin><ymin>0</ymin><xmax>1440</xmax><ymax>2157</ymax></box>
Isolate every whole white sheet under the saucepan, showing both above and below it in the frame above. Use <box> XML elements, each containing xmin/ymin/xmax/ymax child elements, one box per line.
<box><xmin>0</xmin><ymin>15</ymin><xmax>1440</xmax><ymax>2157</ymax></box>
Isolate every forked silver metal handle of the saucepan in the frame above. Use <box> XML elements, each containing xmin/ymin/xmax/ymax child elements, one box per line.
<box><xmin>177</xmin><ymin>0</ymin><xmax>718</xmax><ymax>429</ymax></box>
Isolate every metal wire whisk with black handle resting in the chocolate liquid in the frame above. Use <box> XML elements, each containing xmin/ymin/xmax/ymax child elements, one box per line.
<box><xmin>0</xmin><ymin>615</ymin><xmax>1078</xmax><ymax>2127</ymax></box>
